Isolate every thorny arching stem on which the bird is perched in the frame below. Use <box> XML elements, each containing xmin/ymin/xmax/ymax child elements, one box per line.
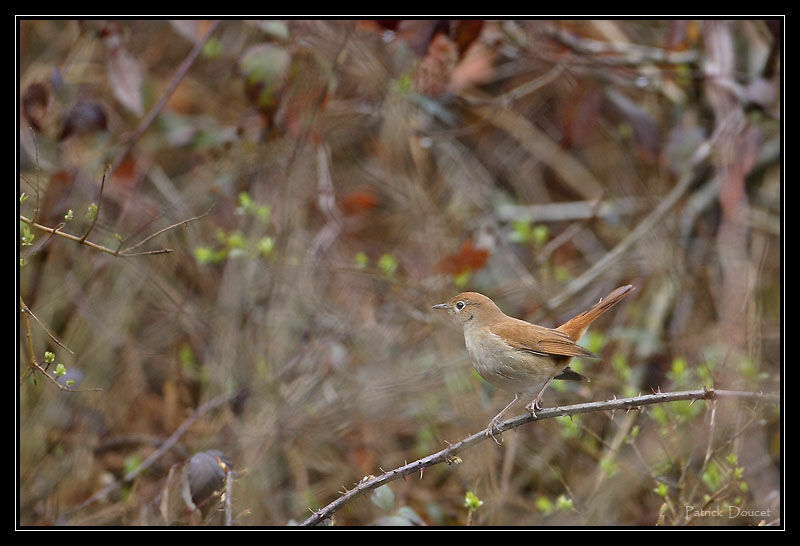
<box><xmin>301</xmin><ymin>388</ymin><xmax>778</xmax><ymax>526</ymax></box>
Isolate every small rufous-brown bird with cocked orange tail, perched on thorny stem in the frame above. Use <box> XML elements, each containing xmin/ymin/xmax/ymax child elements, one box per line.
<box><xmin>433</xmin><ymin>285</ymin><xmax>633</xmax><ymax>441</ymax></box>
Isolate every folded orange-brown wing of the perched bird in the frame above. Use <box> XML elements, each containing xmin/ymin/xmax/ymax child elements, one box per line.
<box><xmin>489</xmin><ymin>319</ymin><xmax>598</xmax><ymax>358</ymax></box>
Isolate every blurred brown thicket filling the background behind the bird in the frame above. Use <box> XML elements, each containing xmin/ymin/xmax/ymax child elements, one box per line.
<box><xmin>18</xmin><ymin>20</ymin><xmax>782</xmax><ymax>526</ymax></box>
